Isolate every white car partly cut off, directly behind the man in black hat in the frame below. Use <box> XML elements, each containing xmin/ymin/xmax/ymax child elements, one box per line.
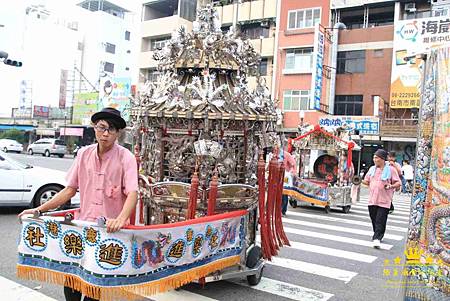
<box><xmin>0</xmin><ymin>151</ymin><xmax>80</xmax><ymax>208</ymax></box>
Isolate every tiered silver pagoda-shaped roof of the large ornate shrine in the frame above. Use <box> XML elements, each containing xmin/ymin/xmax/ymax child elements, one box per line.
<box><xmin>131</xmin><ymin>4</ymin><xmax>277</xmax><ymax>121</ymax></box>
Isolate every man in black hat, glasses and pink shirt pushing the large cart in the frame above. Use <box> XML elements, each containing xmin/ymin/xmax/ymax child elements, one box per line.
<box><xmin>19</xmin><ymin>108</ymin><xmax>138</xmax><ymax>301</ymax></box>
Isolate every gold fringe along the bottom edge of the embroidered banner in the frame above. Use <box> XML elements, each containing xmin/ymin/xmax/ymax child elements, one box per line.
<box><xmin>17</xmin><ymin>255</ymin><xmax>240</xmax><ymax>301</ymax></box>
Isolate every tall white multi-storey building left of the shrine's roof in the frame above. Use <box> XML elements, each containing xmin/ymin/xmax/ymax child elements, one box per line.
<box><xmin>78</xmin><ymin>0</ymin><xmax>139</xmax><ymax>90</ymax></box>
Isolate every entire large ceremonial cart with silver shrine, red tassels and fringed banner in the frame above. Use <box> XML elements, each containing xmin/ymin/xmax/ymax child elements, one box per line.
<box><xmin>18</xmin><ymin>5</ymin><xmax>289</xmax><ymax>300</ymax></box>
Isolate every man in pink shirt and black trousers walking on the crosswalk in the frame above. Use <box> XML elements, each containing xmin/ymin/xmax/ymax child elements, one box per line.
<box><xmin>362</xmin><ymin>149</ymin><xmax>401</xmax><ymax>249</ymax></box>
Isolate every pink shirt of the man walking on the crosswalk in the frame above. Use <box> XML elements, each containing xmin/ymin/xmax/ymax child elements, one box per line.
<box><xmin>364</xmin><ymin>166</ymin><xmax>400</xmax><ymax>208</ymax></box>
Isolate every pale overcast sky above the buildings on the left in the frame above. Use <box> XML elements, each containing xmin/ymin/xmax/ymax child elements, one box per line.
<box><xmin>0</xmin><ymin>0</ymin><xmax>141</xmax><ymax>117</ymax></box>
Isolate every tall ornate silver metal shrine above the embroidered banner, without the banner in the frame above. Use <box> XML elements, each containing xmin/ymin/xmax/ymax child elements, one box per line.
<box><xmin>131</xmin><ymin>4</ymin><xmax>288</xmax><ymax>258</ymax></box>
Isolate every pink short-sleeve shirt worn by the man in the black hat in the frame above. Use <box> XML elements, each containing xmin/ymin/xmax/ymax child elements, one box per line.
<box><xmin>66</xmin><ymin>144</ymin><xmax>138</xmax><ymax>221</ymax></box>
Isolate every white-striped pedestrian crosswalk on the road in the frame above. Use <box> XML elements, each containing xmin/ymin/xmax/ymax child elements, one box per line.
<box><xmin>5</xmin><ymin>191</ymin><xmax>409</xmax><ymax>301</ymax></box>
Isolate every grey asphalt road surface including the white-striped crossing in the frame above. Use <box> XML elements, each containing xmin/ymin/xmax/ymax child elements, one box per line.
<box><xmin>0</xmin><ymin>155</ymin><xmax>409</xmax><ymax>301</ymax></box>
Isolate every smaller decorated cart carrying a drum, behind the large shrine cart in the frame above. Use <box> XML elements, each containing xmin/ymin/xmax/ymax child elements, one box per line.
<box><xmin>283</xmin><ymin>125</ymin><xmax>360</xmax><ymax>213</ymax></box>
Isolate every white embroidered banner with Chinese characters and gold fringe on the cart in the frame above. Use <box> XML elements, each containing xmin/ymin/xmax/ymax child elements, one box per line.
<box><xmin>17</xmin><ymin>210</ymin><xmax>246</xmax><ymax>300</ymax></box>
